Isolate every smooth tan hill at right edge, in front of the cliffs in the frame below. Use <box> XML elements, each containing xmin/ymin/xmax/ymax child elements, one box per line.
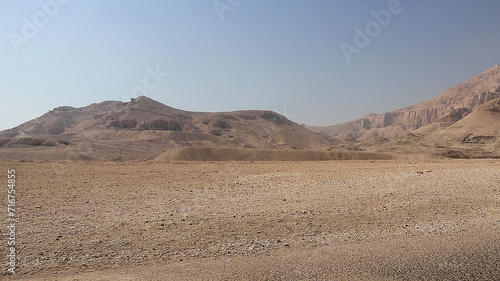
<box><xmin>358</xmin><ymin>98</ymin><xmax>500</xmax><ymax>158</ymax></box>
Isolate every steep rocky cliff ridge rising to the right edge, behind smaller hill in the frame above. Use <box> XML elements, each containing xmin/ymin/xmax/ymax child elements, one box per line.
<box><xmin>310</xmin><ymin>67</ymin><xmax>500</xmax><ymax>141</ymax></box>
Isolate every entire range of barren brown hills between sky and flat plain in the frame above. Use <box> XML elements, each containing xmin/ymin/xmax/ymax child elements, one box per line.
<box><xmin>0</xmin><ymin>66</ymin><xmax>500</xmax><ymax>161</ymax></box>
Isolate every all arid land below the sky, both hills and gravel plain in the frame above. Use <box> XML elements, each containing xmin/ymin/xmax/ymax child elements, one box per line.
<box><xmin>0</xmin><ymin>67</ymin><xmax>500</xmax><ymax>281</ymax></box>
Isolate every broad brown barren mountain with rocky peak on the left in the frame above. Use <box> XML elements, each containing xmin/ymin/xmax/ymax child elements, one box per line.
<box><xmin>0</xmin><ymin>97</ymin><xmax>332</xmax><ymax>159</ymax></box>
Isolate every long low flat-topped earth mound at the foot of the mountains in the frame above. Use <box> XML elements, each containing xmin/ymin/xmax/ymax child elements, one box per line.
<box><xmin>155</xmin><ymin>147</ymin><xmax>391</xmax><ymax>161</ymax></box>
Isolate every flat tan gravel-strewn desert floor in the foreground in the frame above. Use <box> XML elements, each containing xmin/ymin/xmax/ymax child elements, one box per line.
<box><xmin>0</xmin><ymin>157</ymin><xmax>500</xmax><ymax>280</ymax></box>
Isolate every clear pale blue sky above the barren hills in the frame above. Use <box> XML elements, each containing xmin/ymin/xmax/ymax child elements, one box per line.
<box><xmin>0</xmin><ymin>0</ymin><xmax>500</xmax><ymax>129</ymax></box>
